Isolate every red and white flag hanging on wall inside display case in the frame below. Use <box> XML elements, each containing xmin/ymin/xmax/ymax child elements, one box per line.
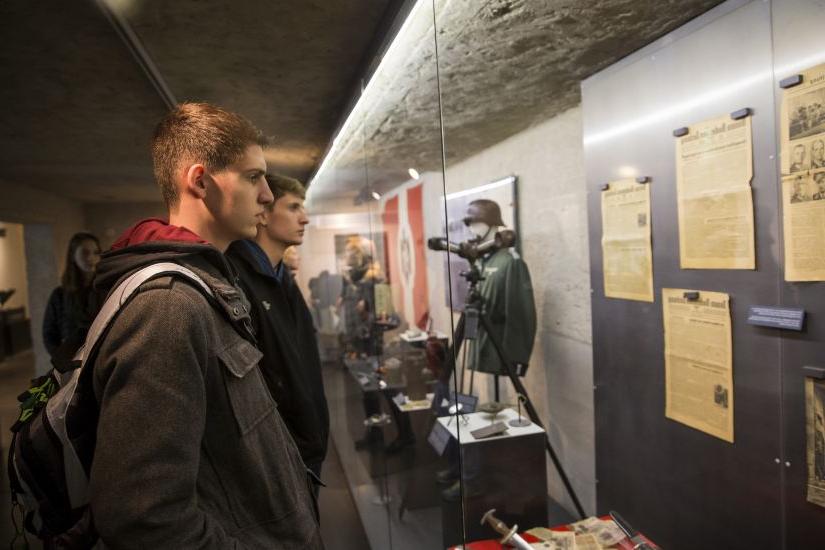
<box><xmin>381</xmin><ymin>183</ymin><xmax>430</xmax><ymax>330</ymax></box>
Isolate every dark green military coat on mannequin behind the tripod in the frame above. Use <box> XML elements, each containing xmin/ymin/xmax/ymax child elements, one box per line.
<box><xmin>468</xmin><ymin>249</ymin><xmax>536</xmax><ymax>375</ymax></box>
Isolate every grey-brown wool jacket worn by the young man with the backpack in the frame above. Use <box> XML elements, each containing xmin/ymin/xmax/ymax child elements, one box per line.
<box><xmin>90</xmin><ymin>243</ymin><xmax>323</xmax><ymax>550</ymax></box>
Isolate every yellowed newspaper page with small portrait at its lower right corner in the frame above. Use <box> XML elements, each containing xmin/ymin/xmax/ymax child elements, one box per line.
<box><xmin>662</xmin><ymin>288</ymin><xmax>733</xmax><ymax>443</ymax></box>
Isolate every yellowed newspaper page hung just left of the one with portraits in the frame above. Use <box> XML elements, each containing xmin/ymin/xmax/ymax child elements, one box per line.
<box><xmin>676</xmin><ymin>115</ymin><xmax>756</xmax><ymax>269</ymax></box>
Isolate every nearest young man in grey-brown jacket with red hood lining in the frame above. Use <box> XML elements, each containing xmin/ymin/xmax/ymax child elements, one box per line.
<box><xmin>90</xmin><ymin>103</ymin><xmax>323</xmax><ymax>549</ymax></box>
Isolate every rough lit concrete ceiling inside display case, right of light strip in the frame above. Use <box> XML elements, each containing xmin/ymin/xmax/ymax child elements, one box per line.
<box><xmin>313</xmin><ymin>0</ymin><xmax>720</xmax><ymax>202</ymax></box>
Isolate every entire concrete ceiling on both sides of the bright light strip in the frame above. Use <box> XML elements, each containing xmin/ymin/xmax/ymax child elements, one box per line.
<box><xmin>0</xmin><ymin>0</ymin><xmax>719</xmax><ymax>206</ymax></box>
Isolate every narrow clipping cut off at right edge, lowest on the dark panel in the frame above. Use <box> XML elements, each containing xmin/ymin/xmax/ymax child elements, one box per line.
<box><xmin>805</xmin><ymin>378</ymin><xmax>825</xmax><ymax>507</ymax></box>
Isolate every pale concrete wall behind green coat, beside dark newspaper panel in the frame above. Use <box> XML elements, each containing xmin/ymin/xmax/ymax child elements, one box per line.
<box><xmin>442</xmin><ymin>107</ymin><xmax>596</xmax><ymax>513</ymax></box>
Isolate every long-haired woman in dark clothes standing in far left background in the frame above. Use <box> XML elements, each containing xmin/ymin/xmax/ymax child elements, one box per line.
<box><xmin>43</xmin><ymin>233</ymin><xmax>100</xmax><ymax>358</ymax></box>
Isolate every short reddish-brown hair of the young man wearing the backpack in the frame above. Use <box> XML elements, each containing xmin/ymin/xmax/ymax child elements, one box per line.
<box><xmin>152</xmin><ymin>103</ymin><xmax>267</xmax><ymax>208</ymax></box>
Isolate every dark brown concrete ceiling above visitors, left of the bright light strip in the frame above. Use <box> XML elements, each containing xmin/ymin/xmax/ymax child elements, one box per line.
<box><xmin>0</xmin><ymin>0</ymin><xmax>401</xmax><ymax>202</ymax></box>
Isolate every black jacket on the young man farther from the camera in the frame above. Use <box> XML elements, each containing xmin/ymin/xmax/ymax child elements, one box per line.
<box><xmin>226</xmin><ymin>241</ymin><xmax>329</xmax><ymax>474</ymax></box>
